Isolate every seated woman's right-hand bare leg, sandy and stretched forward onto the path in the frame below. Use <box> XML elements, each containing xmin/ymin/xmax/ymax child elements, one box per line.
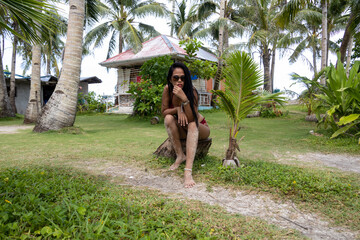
<box><xmin>184</xmin><ymin>122</ymin><xmax>199</xmax><ymax>188</ymax></box>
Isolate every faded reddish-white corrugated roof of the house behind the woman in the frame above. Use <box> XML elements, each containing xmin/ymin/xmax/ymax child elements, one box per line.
<box><xmin>99</xmin><ymin>35</ymin><xmax>217</xmax><ymax>68</ymax></box>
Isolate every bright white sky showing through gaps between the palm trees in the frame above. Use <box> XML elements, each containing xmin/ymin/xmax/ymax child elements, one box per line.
<box><xmin>3</xmin><ymin>0</ymin><xmax>341</xmax><ymax>95</ymax></box>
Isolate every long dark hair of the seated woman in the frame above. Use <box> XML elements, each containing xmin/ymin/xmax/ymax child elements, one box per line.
<box><xmin>167</xmin><ymin>62</ymin><xmax>199</xmax><ymax>126</ymax></box>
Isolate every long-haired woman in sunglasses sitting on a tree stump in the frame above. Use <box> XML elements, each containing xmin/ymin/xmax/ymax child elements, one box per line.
<box><xmin>161</xmin><ymin>63</ymin><xmax>210</xmax><ymax>188</ymax></box>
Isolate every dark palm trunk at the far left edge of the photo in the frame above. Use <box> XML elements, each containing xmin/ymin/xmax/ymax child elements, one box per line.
<box><xmin>0</xmin><ymin>48</ymin><xmax>15</xmax><ymax>117</ymax></box>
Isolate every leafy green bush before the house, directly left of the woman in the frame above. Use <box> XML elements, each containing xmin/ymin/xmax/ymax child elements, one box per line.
<box><xmin>128</xmin><ymin>80</ymin><xmax>164</xmax><ymax>117</ymax></box>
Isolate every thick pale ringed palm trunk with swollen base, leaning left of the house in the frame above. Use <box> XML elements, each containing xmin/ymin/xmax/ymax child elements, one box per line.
<box><xmin>34</xmin><ymin>0</ymin><xmax>85</xmax><ymax>132</ymax></box>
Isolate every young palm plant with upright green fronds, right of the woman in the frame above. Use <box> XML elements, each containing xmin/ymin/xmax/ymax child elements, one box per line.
<box><xmin>214</xmin><ymin>51</ymin><xmax>285</xmax><ymax>166</ymax></box>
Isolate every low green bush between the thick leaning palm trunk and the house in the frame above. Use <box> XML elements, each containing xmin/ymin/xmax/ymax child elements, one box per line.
<box><xmin>77</xmin><ymin>92</ymin><xmax>106</xmax><ymax>113</ymax></box>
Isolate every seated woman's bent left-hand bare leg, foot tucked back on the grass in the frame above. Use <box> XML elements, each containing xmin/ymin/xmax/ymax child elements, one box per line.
<box><xmin>164</xmin><ymin>115</ymin><xmax>186</xmax><ymax>170</ymax></box>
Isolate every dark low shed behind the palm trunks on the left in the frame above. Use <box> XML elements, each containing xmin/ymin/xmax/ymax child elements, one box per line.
<box><xmin>4</xmin><ymin>72</ymin><xmax>102</xmax><ymax>114</ymax></box>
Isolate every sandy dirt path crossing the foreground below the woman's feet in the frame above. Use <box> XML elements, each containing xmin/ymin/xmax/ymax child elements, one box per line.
<box><xmin>79</xmin><ymin>162</ymin><xmax>360</xmax><ymax>239</ymax></box>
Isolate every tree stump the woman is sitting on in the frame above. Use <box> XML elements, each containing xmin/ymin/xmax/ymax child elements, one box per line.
<box><xmin>154</xmin><ymin>138</ymin><xmax>212</xmax><ymax>159</ymax></box>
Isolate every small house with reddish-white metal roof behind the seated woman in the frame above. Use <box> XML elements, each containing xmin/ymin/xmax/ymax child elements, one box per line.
<box><xmin>99</xmin><ymin>35</ymin><xmax>221</xmax><ymax>113</ymax></box>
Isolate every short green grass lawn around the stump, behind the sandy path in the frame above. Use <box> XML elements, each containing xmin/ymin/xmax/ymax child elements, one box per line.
<box><xmin>0</xmin><ymin>106</ymin><xmax>360</xmax><ymax>238</ymax></box>
